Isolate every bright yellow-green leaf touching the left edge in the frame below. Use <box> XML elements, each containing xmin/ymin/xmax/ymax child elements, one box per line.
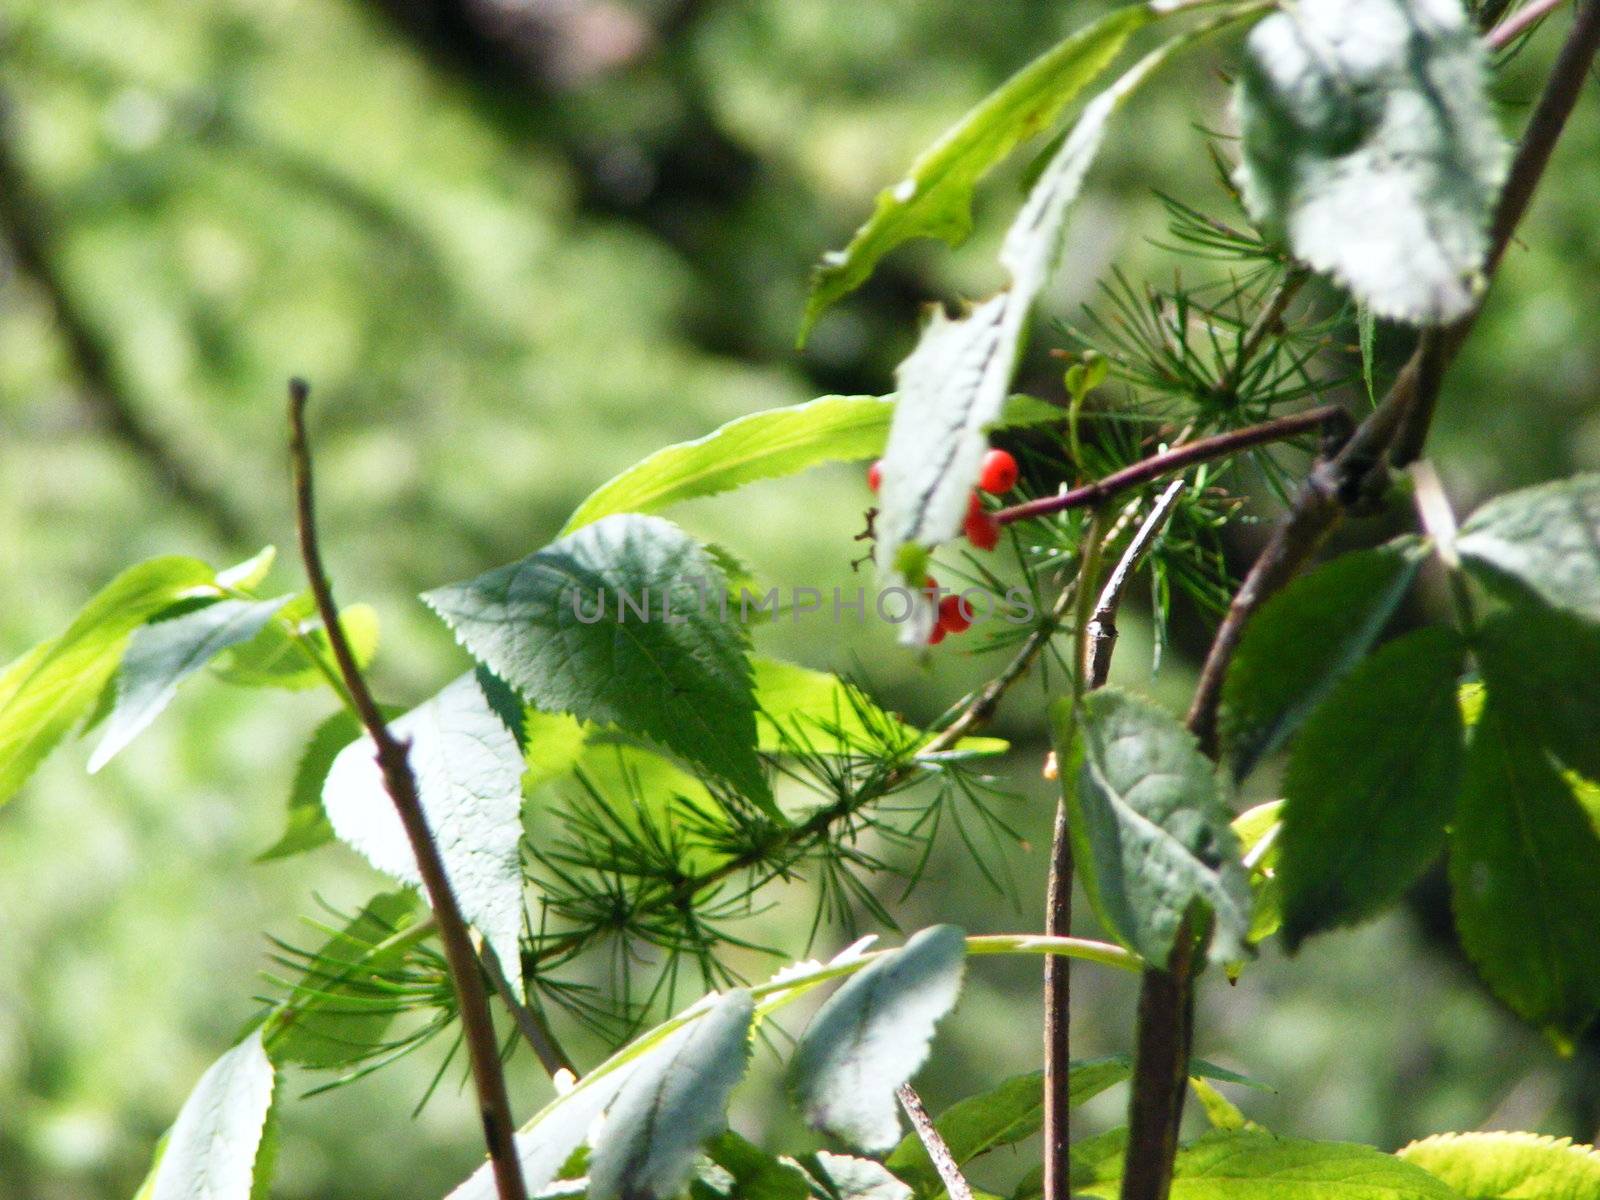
<box><xmin>0</xmin><ymin>557</ymin><xmax>214</xmax><ymax>805</ymax></box>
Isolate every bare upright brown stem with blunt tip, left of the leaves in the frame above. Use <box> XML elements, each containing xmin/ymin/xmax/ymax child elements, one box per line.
<box><xmin>290</xmin><ymin>379</ymin><xmax>528</xmax><ymax>1200</ymax></box>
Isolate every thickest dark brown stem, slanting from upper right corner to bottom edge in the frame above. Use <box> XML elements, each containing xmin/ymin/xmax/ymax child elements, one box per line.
<box><xmin>1122</xmin><ymin>9</ymin><xmax>1600</xmax><ymax>1200</ymax></box>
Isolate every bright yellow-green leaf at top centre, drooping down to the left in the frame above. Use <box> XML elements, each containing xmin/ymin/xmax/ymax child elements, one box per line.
<box><xmin>800</xmin><ymin>3</ymin><xmax>1160</xmax><ymax>342</ymax></box>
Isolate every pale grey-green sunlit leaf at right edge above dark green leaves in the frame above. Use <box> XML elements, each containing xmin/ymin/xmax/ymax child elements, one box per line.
<box><xmin>1456</xmin><ymin>474</ymin><xmax>1600</xmax><ymax>622</ymax></box>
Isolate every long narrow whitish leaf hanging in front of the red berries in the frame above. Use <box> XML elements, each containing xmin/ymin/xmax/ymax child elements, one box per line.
<box><xmin>877</xmin><ymin>40</ymin><xmax>1190</xmax><ymax>620</ymax></box>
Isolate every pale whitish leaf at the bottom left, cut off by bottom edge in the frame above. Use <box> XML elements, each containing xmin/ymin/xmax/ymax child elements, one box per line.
<box><xmin>139</xmin><ymin>1029</ymin><xmax>277</xmax><ymax>1200</ymax></box>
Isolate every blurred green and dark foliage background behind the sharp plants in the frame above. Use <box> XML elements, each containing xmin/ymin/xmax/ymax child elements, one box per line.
<box><xmin>0</xmin><ymin>0</ymin><xmax>1600</xmax><ymax>1200</ymax></box>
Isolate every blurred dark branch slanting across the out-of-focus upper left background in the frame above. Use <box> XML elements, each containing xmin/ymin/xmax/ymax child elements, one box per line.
<box><xmin>0</xmin><ymin>96</ymin><xmax>250</xmax><ymax>546</ymax></box>
